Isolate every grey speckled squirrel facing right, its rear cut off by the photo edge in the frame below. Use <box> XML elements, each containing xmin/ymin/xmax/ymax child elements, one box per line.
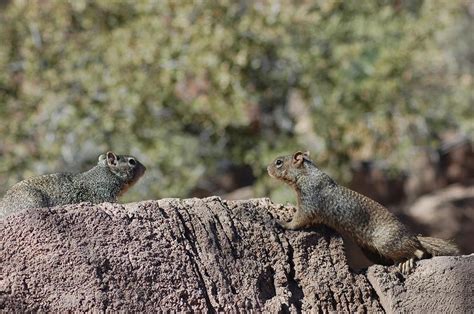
<box><xmin>0</xmin><ymin>152</ymin><xmax>146</xmax><ymax>218</ymax></box>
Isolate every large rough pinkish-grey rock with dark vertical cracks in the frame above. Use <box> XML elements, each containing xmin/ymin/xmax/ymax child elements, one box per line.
<box><xmin>0</xmin><ymin>197</ymin><xmax>382</xmax><ymax>312</ymax></box>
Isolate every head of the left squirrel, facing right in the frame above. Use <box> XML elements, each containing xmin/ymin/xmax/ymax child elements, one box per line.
<box><xmin>97</xmin><ymin>151</ymin><xmax>146</xmax><ymax>195</ymax></box>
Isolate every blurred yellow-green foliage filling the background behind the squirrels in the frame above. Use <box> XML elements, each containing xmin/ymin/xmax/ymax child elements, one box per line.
<box><xmin>0</xmin><ymin>0</ymin><xmax>474</xmax><ymax>199</ymax></box>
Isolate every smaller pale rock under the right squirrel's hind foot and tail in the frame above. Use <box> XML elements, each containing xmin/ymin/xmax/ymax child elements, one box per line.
<box><xmin>367</xmin><ymin>254</ymin><xmax>474</xmax><ymax>313</ymax></box>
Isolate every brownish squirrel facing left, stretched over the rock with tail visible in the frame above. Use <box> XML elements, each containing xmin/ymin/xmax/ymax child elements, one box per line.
<box><xmin>267</xmin><ymin>152</ymin><xmax>459</xmax><ymax>273</ymax></box>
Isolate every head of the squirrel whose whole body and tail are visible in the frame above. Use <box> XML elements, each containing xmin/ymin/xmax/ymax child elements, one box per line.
<box><xmin>267</xmin><ymin>151</ymin><xmax>310</xmax><ymax>185</ymax></box>
